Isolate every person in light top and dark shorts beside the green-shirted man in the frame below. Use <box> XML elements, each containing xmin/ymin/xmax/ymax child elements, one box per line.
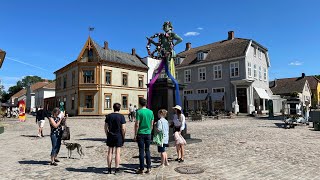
<box><xmin>156</xmin><ymin>109</ymin><xmax>169</xmax><ymax>167</ymax></box>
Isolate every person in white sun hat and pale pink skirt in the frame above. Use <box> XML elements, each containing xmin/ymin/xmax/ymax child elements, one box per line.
<box><xmin>173</xmin><ymin>105</ymin><xmax>186</xmax><ymax>163</ymax></box>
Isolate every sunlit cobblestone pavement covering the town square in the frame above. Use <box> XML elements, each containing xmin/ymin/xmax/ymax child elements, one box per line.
<box><xmin>0</xmin><ymin>116</ymin><xmax>320</xmax><ymax>180</ymax></box>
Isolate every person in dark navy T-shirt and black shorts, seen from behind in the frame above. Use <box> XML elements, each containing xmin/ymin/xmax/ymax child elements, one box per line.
<box><xmin>104</xmin><ymin>103</ymin><xmax>126</xmax><ymax>174</ymax></box>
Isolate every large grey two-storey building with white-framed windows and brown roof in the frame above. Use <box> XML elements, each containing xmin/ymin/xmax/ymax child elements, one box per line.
<box><xmin>176</xmin><ymin>31</ymin><xmax>272</xmax><ymax>113</ymax></box>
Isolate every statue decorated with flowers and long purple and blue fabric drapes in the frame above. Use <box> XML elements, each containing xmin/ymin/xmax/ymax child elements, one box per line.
<box><xmin>147</xmin><ymin>21</ymin><xmax>182</xmax><ymax>108</ymax></box>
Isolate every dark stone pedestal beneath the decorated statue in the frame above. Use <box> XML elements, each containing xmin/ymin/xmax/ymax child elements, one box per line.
<box><xmin>148</xmin><ymin>78</ymin><xmax>191</xmax><ymax>141</ymax></box>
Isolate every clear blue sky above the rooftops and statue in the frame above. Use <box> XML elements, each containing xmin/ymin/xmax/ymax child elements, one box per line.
<box><xmin>0</xmin><ymin>0</ymin><xmax>320</xmax><ymax>88</ymax></box>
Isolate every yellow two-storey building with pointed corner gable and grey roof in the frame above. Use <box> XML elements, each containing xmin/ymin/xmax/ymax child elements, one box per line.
<box><xmin>55</xmin><ymin>37</ymin><xmax>148</xmax><ymax>115</ymax></box>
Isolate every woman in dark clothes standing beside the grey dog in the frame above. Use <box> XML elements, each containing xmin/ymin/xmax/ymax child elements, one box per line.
<box><xmin>49</xmin><ymin>108</ymin><xmax>66</xmax><ymax>166</ymax></box>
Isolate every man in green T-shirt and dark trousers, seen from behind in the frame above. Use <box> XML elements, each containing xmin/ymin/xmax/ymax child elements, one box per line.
<box><xmin>134</xmin><ymin>98</ymin><xmax>154</xmax><ymax>174</ymax></box>
